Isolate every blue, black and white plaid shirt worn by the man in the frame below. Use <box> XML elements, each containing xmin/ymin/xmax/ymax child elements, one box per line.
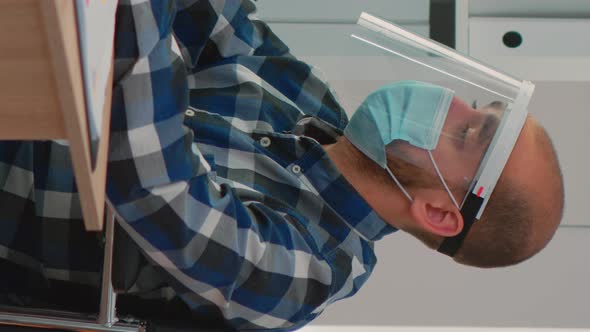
<box><xmin>0</xmin><ymin>0</ymin><xmax>394</xmax><ymax>329</ymax></box>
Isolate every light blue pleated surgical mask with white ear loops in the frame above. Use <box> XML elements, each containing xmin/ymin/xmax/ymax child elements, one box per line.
<box><xmin>344</xmin><ymin>81</ymin><xmax>457</xmax><ymax>205</ymax></box>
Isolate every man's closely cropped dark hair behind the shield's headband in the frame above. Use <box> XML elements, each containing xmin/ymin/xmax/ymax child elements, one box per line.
<box><xmin>454</xmin><ymin>121</ymin><xmax>565</xmax><ymax>267</ymax></box>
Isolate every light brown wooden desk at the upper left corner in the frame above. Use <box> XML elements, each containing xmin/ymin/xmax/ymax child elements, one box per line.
<box><xmin>0</xmin><ymin>0</ymin><xmax>112</xmax><ymax>231</ymax></box>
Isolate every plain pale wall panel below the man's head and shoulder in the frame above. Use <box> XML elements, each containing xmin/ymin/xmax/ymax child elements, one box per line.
<box><xmin>315</xmin><ymin>228</ymin><xmax>590</xmax><ymax>328</ymax></box>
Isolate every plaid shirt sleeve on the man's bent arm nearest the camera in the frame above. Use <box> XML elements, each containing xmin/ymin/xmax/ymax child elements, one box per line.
<box><xmin>107</xmin><ymin>0</ymin><xmax>364</xmax><ymax>330</ymax></box>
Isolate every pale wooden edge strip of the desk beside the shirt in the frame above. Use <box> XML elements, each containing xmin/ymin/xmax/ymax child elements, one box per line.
<box><xmin>39</xmin><ymin>0</ymin><xmax>113</xmax><ymax>231</ymax></box>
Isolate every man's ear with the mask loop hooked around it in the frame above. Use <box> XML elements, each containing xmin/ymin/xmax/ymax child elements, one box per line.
<box><xmin>410</xmin><ymin>189</ymin><xmax>463</xmax><ymax>237</ymax></box>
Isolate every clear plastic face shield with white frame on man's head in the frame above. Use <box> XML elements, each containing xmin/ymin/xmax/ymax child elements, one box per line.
<box><xmin>312</xmin><ymin>13</ymin><xmax>534</xmax><ymax>256</ymax></box>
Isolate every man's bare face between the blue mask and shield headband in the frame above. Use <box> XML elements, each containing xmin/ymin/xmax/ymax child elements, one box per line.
<box><xmin>388</xmin><ymin>97</ymin><xmax>503</xmax><ymax>202</ymax></box>
